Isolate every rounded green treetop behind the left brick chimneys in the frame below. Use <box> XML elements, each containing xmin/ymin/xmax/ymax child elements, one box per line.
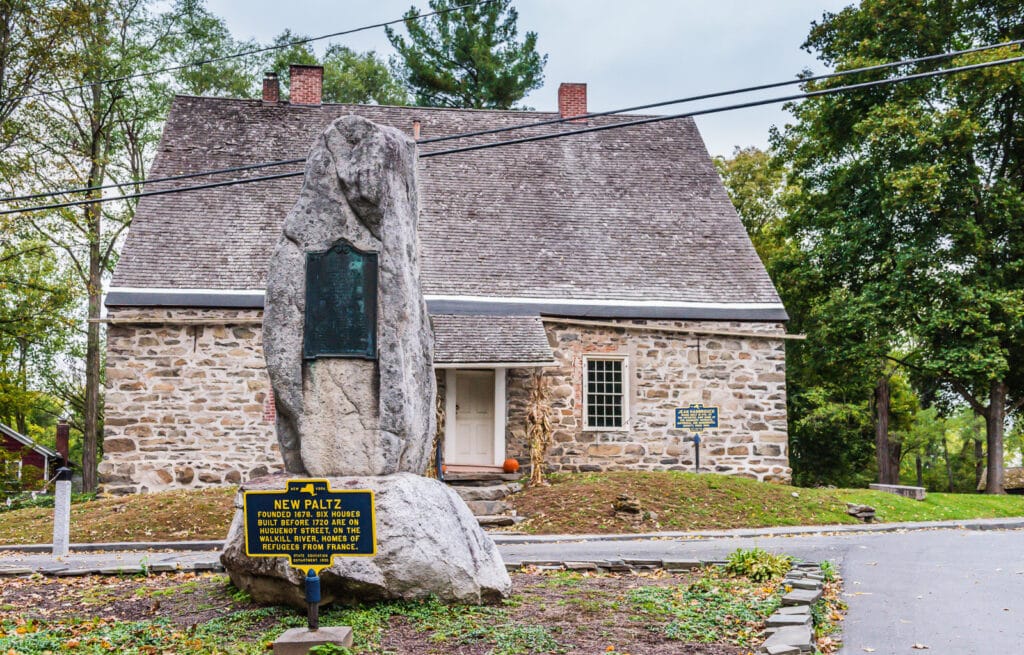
<box><xmin>265</xmin><ymin>30</ymin><xmax>409</xmax><ymax>104</ymax></box>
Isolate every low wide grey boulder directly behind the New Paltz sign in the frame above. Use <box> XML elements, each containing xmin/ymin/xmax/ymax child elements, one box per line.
<box><xmin>220</xmin><ymin>473</ymin><xmax>512</xmax><ymax>609</ymax></box>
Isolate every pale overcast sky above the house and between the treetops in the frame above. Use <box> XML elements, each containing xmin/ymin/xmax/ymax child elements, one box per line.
<box><xmin>208</xmin><ymin>0</ymin><xmax>851</xmax><ymax>155</ymax></box>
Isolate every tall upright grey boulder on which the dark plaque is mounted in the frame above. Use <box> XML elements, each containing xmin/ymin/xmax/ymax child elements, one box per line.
<box><xmin>263</xmin><ymin>116</ymin><xmax>436</xmax><ymax>477</ymax></box>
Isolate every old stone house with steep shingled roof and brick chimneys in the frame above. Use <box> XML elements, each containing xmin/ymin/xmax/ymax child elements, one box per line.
<box><xmin>100</xmin><ymin>67</ymin><xmax>791</xmax><ymax>492</ymax></box>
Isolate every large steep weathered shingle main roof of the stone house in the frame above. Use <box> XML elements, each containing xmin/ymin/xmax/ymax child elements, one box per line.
<box><xmin>108</xmin><ymin>96</ymin><xmax>785</xmax><ymax>320</ymax></box>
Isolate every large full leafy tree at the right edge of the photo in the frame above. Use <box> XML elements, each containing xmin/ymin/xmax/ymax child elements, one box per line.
<box><xmin>774</xmin><ymin>0</ymin><xmax>1024</xmax><ymax>493</ymax></box>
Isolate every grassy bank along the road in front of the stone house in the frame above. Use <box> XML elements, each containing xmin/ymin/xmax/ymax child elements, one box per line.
<box><xmin>0</xmin><ymin>471</ymin><xmax>1024</xmax><ymax>543</ymax></box>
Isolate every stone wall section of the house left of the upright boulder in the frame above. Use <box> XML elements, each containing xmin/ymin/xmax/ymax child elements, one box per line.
<box><xmin>99</xmin><ymin>309</ymin><xmax>283</xmax><ymax>493</ymax></box>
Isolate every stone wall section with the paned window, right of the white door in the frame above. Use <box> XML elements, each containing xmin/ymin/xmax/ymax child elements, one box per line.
<box><xmin>506</xmin><ymin>321</ymin><xmax>791</xmax><ymax>481</ymax></box>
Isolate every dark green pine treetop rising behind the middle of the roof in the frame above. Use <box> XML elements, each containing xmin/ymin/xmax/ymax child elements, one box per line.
<box><xmin>387</xmin><ymin>0</ymin><xmax>548</xmax><ymax>110</ymax></box>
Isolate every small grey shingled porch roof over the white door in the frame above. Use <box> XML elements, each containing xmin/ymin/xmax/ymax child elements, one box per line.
<box><xmin>430</xmin><ymin>314</ymin><xmax>554</xmax><ymax>364</ymax></box>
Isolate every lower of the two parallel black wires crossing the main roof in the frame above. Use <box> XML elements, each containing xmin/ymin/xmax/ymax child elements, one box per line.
<box><xmin>0</xmin><ymin>50</ymin><xmax>1024</xmax><ymax>216</ymax></box>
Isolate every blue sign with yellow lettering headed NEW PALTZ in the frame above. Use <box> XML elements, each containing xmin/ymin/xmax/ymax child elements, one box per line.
<box><xmin>243</xmin><ymin>480</ymin><xmax>377</xmax><ymax>573</ymax></box>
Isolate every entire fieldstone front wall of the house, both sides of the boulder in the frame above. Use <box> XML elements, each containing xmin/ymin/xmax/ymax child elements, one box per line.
<box><xmin>99</xmin><ymin>309</ymin><xmax>791</xmax><ymax>493</ymax></box>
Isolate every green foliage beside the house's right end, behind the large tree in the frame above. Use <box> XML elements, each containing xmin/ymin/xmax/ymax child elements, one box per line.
<box><xmin>716</xmin><ymin>147</ymin><xmax>912</xmax><ymax>485</ymax></box>
